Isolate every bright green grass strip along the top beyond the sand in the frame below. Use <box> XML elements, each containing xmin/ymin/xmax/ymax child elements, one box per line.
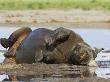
<box><xmin>0</xmin><ymin>0</ymin><xmax>110</xmax><ymax>10</ymax></box>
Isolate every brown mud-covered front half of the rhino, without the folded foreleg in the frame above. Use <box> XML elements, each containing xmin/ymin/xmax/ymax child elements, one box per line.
<box><xmin>44</xmin><ymin>28</ymin><xmax>95</xmax><ymax>65</ymax></box>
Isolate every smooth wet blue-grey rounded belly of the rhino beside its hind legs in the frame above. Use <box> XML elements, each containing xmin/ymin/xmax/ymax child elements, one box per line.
<box><xmin>16</xmin><ymin>28</ymin><xmax>53</xmax><ymax>64</ymax></box>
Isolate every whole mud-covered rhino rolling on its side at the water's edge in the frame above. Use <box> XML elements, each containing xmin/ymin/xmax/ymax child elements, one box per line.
<box><xmin>0</xmin><ymin>27</ymin><xmax>101</xmax><ymax>66</ymax></box>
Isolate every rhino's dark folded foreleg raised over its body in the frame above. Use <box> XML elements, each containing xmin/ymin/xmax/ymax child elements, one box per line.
<box><xmin>45</xmin><ymin>27</ymin><xmax>71</xmax><ymax>46</ymax></box>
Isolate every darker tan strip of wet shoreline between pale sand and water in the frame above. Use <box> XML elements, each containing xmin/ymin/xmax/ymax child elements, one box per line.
<box><xmin>0</xmin><ymin>23</ymin><xmax>110</xmax><ymax>29</ymax></box>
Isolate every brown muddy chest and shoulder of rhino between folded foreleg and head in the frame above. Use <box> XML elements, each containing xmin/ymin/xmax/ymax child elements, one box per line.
<box><xmin>45</xmin><ymin>28</ymin><xmax>83</xmax><ymax>63</ymax></box>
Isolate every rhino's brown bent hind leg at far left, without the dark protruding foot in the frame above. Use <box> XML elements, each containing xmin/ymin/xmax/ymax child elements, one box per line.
<box><xmin>4</xmin><ymin>27</ymin><xmax>31</xmax><ymax>57</ymax></box>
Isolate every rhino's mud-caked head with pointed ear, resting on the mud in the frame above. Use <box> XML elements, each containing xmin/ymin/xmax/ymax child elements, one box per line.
<box><xmin>70</xmin><ymin>42</ymin><xmax>103</xmax><ymax>66</ymax></box>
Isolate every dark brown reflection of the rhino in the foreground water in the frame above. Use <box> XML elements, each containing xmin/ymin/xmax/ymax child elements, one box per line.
<box><xmin>1</xmin><ymin>65</ymin><xmax>96</xmax><ymax>82</ymax></box>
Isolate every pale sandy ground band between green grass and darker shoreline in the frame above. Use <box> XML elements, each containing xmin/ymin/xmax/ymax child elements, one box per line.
<box><xmin>0</xmin><ymin>9</ymin><xmax>110</xmax><ymax>24</ymax></box>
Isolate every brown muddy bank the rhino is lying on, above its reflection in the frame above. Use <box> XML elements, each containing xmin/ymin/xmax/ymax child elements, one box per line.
<box><xmin>0</xmin><ymin>63</ymin><xmax>92</xmax><ymax>76</ymax></box>
